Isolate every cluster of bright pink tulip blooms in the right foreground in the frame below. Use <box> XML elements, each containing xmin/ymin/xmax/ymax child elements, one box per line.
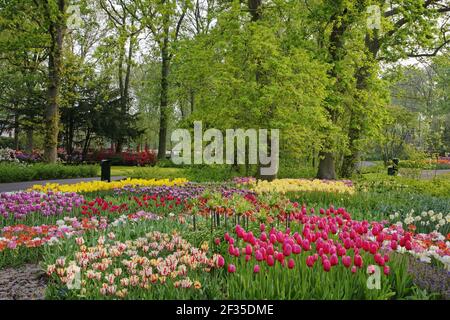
<box><xmin>224</xmin><ymin>207</ymin><xmax>420</xmax><ymax>275</ymax></box>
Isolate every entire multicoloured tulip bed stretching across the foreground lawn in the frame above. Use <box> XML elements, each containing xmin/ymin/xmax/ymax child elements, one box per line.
<box><xmin>0</xmin><ymin>178</ymin><xmax>450</xmax><ymax>299</ymax></box>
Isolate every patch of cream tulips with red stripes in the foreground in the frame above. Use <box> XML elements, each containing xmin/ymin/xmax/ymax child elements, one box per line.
<box><xmin>47</xmin><ymin>231</ymin><xmax>223</xmax><ymax>299</ymax></box>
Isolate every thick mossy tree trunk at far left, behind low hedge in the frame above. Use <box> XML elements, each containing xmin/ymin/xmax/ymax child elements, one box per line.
<box><xmin>44</xmin><ymin>0</ymin><xmax>66</xmax><ymax>163</ymax></box>
